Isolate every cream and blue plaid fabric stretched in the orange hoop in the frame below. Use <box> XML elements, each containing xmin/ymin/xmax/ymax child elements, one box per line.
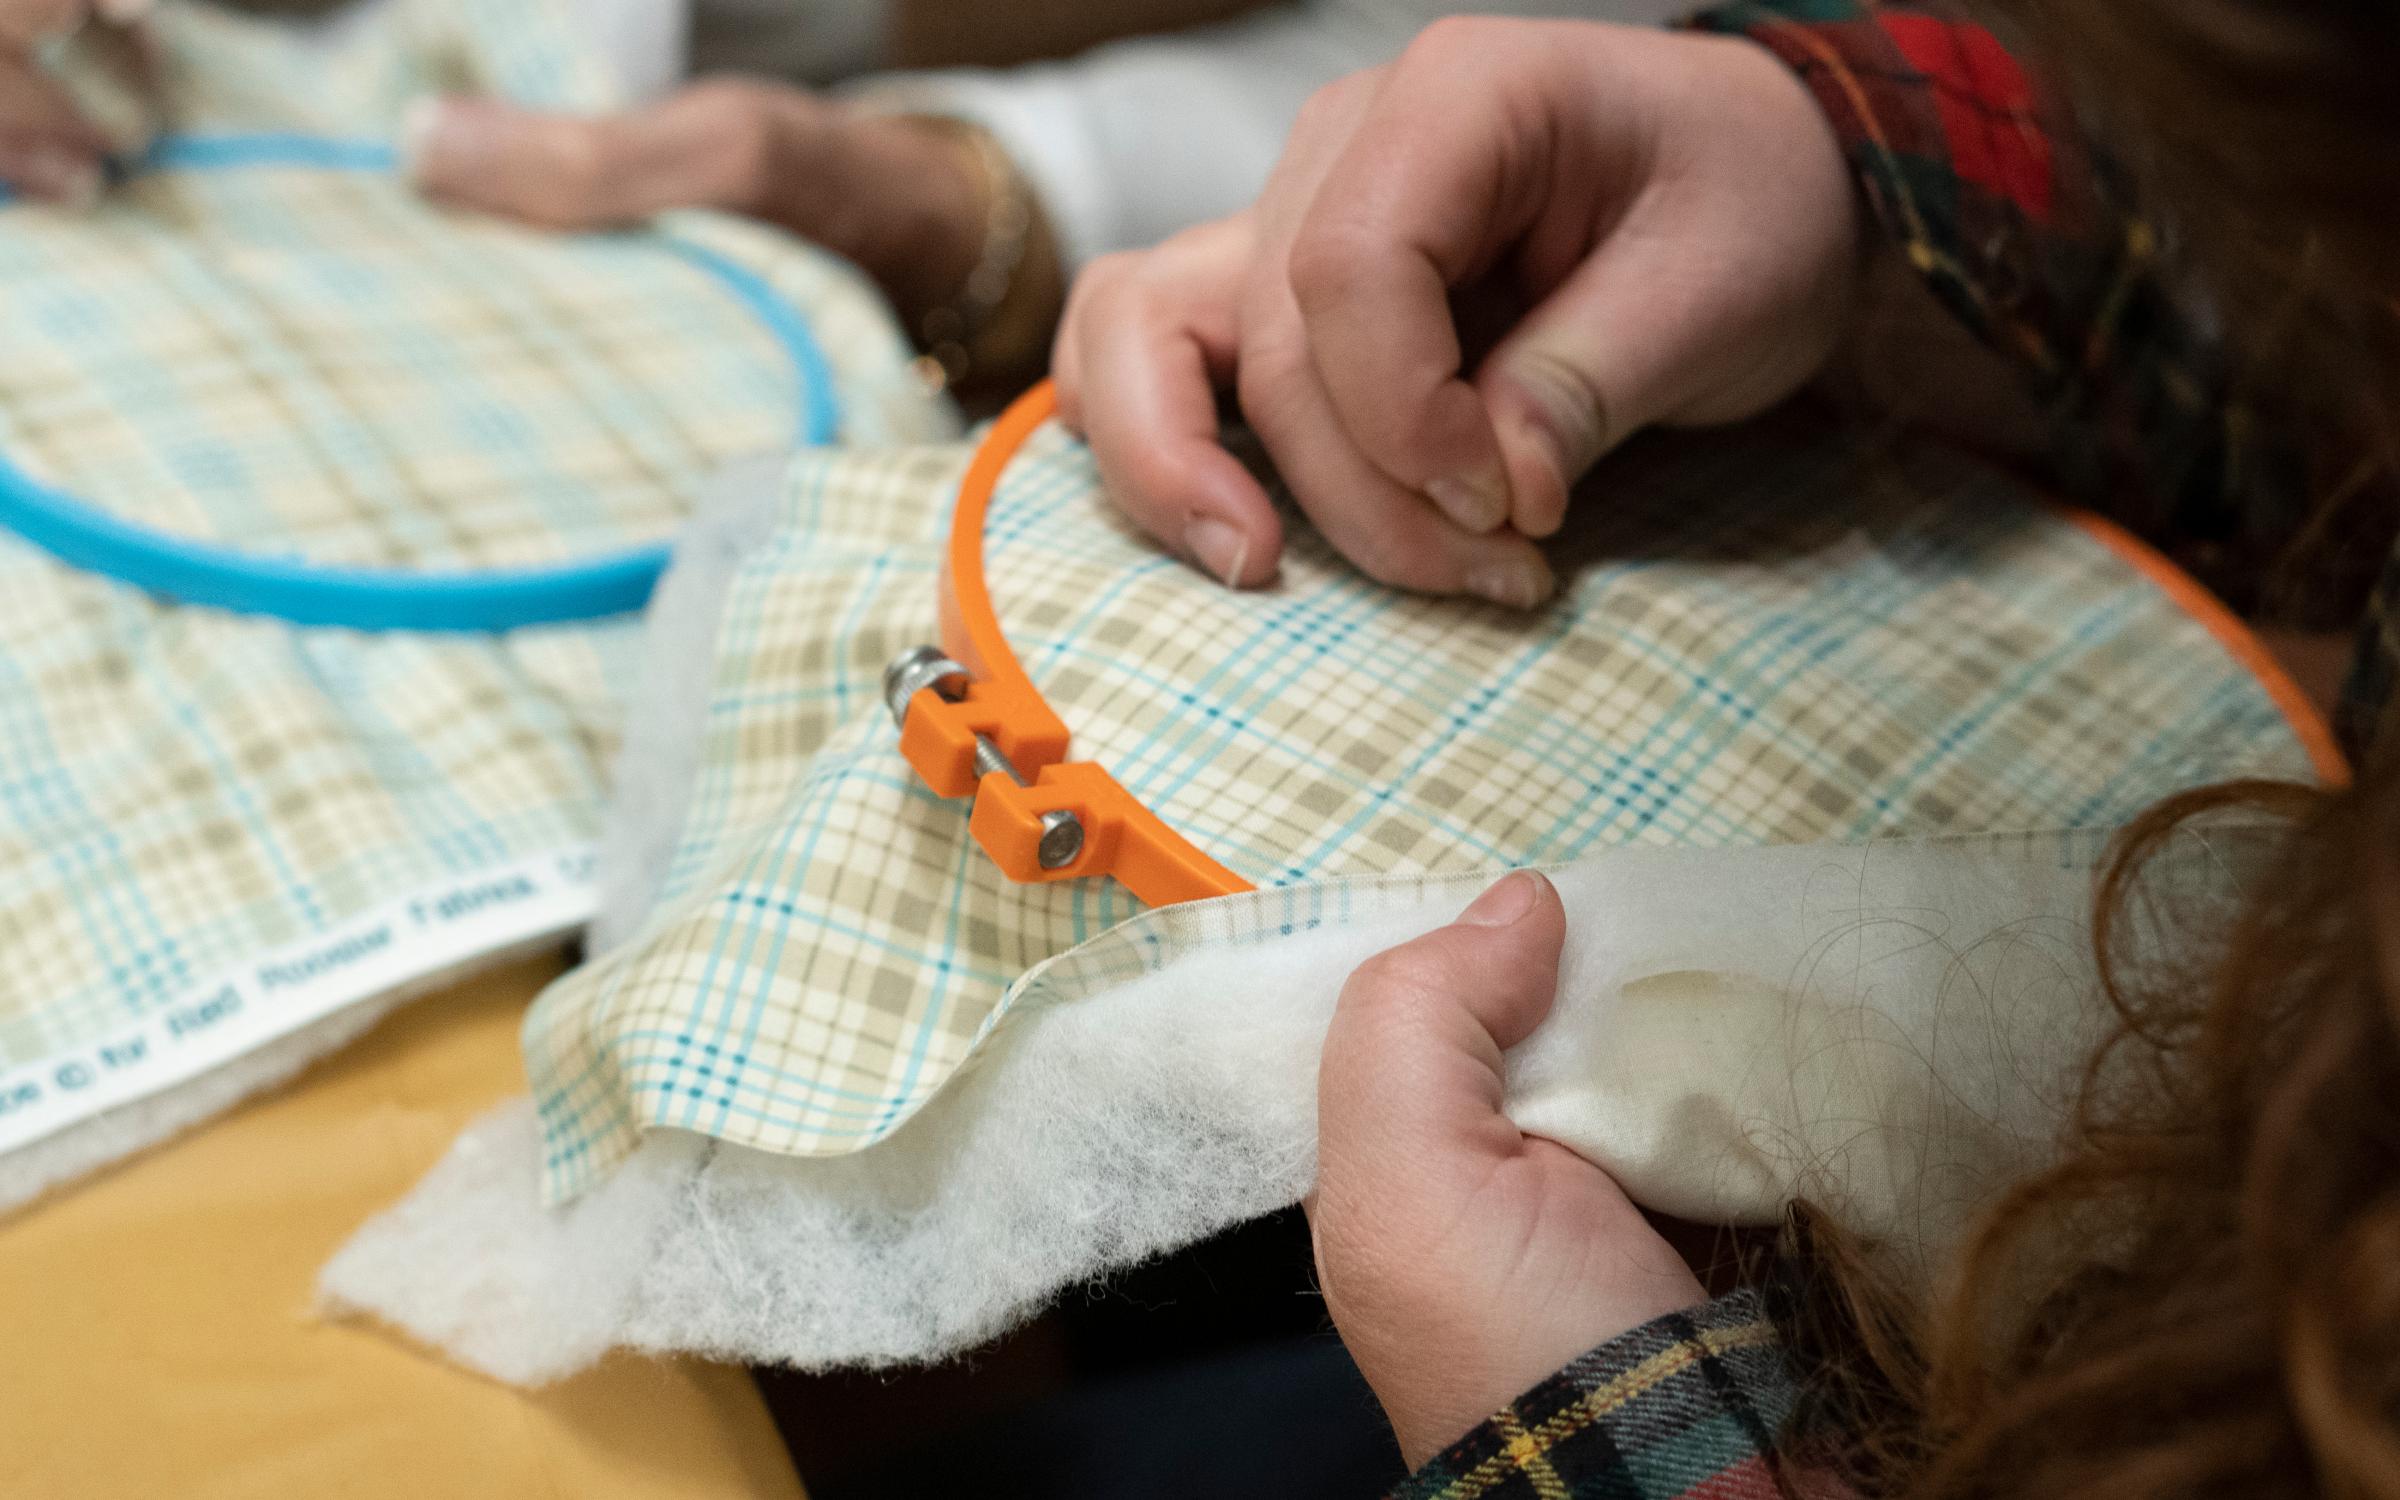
<box><xmin>526</xmin><ymin>403</ymin><xmax>2311</xmax><ymax>1198</ymax></box>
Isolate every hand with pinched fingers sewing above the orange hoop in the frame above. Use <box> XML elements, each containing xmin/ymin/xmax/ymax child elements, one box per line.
<box><xmin>1054</xmin><ymin>19</ymin><xmax>1860</xmax><ymax>605</ymax></box>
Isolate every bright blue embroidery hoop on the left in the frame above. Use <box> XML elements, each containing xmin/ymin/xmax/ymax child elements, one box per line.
<box><xmin>0</xmin><ymin>134</ymin><xmax>840</xmax><ymax>634</ymax></box>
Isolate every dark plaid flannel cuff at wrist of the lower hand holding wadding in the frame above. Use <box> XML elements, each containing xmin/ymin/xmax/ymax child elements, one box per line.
<box><xmin>1392</xmin><ymin>1289</ymin><xmax>1798</xmax><ymax>1500</ymax></box>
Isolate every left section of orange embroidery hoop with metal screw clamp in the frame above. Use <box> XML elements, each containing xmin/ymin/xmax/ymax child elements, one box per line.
<box><xmin>883</xmin><ymin>382</ymin><xmax>1253</xmax><ymax>907</ymax></box>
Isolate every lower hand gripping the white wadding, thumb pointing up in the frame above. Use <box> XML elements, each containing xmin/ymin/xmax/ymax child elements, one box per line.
<box><xmin>1308</xmin><ymin>874</ymin><xmax>1706</xmax><ymax>1469</ymax></box>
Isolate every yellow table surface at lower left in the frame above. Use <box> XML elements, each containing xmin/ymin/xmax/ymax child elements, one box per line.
<box><xmin>0</xmin><ymin>960</ymin><xmax>802</xmax><ymax>1500</ymax></box>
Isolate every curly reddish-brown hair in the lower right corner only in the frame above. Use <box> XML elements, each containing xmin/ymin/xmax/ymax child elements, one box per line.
<box><xmin>1786</xmin><ymin>780</ymin><xmax>2400</xmax><ymax>1500</ymax></box>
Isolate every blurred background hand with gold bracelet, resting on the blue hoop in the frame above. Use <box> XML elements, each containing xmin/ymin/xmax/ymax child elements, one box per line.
<box><xmin>410</xmin><ymin>83</ymin><xmax>989</xmax><ymax>340</ymax></box>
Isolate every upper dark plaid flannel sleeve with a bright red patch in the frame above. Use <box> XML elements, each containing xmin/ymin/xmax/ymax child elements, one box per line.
<box><xmin>1694</xmin><ymin>0</ymin><xmax>2400</xmax><ymax>754</ymax></box>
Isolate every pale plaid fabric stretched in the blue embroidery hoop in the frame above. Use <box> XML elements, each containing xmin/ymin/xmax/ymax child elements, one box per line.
<box><xmin>0</xmin><ymin>0</ymin><xmax>946</xmax><ymax>1166</ymax></box>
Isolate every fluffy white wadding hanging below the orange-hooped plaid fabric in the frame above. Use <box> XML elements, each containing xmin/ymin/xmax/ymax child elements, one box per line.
<box><xmin>322</xmin><ymin>828</ymin><xmax>2263</xmax><ymax>1382</ymax></box>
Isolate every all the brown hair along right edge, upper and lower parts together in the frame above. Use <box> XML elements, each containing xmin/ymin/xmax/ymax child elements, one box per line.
<box><xmin>1781</xmin><ymin>0</ymin><xmax>2400</xmax><ymax>1500</ymax></box>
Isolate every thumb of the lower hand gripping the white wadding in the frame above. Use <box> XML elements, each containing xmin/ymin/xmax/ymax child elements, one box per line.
<box><xmin>1318</xmin><ymin>871</ymin><xmax>1567</xmax><ymax>1217</ymax></box>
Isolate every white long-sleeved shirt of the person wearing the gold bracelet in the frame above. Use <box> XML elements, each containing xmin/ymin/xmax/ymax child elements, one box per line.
<box><xmin>581</xmin><ymin>0</ymin><xmax>1690</xmax><ymax>264</ymax></box>
